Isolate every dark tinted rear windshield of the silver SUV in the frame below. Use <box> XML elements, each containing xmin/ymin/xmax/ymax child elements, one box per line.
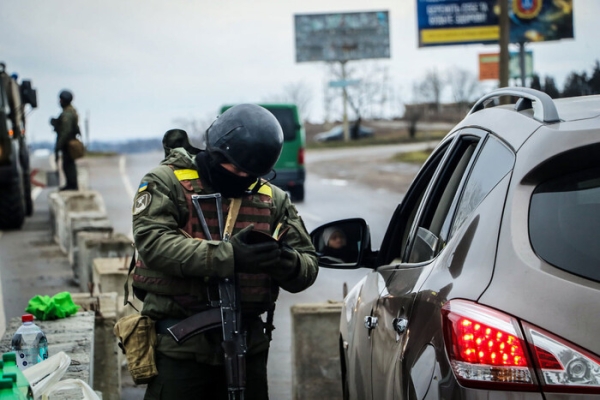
<box><xmin>529</xmin><ymin>168</ymin><xmax>600</xmax><ymax>282</ymax></box>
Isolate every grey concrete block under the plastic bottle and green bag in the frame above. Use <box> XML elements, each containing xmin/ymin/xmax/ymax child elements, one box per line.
<box><xmin>0</xmin><ymin>312</ymin><xmax>95</xmax><ymax>400</ymax></box>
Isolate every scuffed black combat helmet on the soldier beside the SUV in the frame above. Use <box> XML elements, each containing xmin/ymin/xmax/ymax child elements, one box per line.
<box><xmin>206</xmin><ymin>104</ymin><xmax>283</xmax><ymax>177</ymax></box>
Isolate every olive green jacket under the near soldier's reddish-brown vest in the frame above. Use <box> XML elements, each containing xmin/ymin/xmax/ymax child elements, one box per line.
<box><xmin>133</xmin><ymin>148</ymin><xmax>318</xmax><ymax>364</ymax></box>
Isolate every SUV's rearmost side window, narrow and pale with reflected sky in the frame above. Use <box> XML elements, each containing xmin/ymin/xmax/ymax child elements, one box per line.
<box><xmin>448</xmin><ymin>136</ymin><xmax>515</xmax><ymax>242</ymax></box>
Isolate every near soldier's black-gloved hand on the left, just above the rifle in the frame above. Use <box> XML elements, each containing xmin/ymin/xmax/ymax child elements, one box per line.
<box><xmin>229</xmin><ymin>225</ymin><xmax>281</xmax><ymax>273</ymax></box>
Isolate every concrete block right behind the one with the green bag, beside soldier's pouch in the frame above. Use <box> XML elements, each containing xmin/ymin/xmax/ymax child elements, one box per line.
<box><xmin>71</xmin><ymin>292</ymin><xmax>123</xmax><ymax>400</ymax></box>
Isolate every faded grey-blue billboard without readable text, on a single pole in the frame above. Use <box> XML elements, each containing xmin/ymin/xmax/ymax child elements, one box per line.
<box><xmin>294</xmin><ymin>11</ymin><xmax>390</xmax><ymax>62</ymax></box>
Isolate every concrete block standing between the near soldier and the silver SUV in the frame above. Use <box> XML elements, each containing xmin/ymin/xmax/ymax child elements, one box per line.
<box><xmin>290</xmin><ymin>302</ymin><xmax>342</xmax><ymax>400</ymax></box>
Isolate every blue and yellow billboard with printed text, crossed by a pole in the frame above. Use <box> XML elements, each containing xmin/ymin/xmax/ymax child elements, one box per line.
<box><xmin>416</xmin><ymin>0</ymin><xmax>574</xmax><ymax>47</ymax></box>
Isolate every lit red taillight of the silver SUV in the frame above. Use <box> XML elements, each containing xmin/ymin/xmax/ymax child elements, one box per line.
<box><xmin>442</xmin><ymin>300</ymin><xmax>600</xmax><ymax>393</ymax></box>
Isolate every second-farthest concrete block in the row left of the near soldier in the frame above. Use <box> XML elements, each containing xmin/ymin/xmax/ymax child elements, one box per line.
<box><xmin>65</xmin><ymin>211</ymin><xmax>114</xmax><ymax>266</ymax></box>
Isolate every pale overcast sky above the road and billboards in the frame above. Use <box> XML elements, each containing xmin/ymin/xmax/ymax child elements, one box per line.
<box><xmin>0</xmin><ymin>0</ymin><xmax>600</xmax><ymax>141</ymax></box>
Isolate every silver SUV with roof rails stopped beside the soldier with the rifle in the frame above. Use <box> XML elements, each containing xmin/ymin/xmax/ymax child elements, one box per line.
<box><xmin>311</xmin><ymin>88</ymin><xmax>600</xmax><ymax>400</ymax></box>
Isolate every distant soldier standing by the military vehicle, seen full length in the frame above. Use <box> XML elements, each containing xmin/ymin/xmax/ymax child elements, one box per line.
<box><xmin>50</xmin><ymin>90</ymin><xmax>79</xmax><ymax>190</ymax></box>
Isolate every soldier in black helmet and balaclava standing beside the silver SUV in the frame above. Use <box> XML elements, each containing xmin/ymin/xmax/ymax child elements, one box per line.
<box><xmin>133</xmin><ymin>104</ymin><xmax>318</xmax><ymax>400</ymax></box>
